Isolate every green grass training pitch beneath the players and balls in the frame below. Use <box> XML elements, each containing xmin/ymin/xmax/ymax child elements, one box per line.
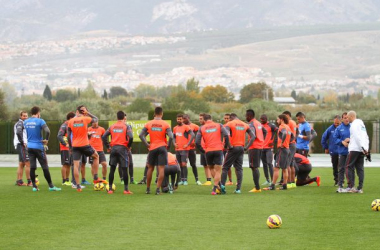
<box><xmin>0</xmin><ymin>168</ymin><xmax>380</xmax><ymax>249</ymax></box>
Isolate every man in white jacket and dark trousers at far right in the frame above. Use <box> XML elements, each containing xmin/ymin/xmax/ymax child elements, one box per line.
<box><xmin>346</xmin><ymin>111</ymin><xmax>369</xmax><ymax>193</ymax></box>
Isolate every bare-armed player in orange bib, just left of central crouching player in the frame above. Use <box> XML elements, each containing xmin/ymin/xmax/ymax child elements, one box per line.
<box><xmin>139</xmin><ymin>107</ymin><xmax>176</xmax><ymax>194</ymax></box>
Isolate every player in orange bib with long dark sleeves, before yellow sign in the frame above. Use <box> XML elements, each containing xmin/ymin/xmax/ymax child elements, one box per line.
<box><xmin>102</xmin><ymin>111</ymin><xmax>133</xmax><ymax>194</ymax></box>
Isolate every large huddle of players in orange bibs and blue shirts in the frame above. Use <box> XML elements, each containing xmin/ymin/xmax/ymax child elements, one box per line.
<box><xmin>14</xmin><ymin>106</ymin><xmax>320</xmax><ymax>195</ymax></box>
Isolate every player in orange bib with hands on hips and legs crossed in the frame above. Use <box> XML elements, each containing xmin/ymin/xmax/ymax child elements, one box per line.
<box><xmin>195</xmin><ymin>114</ymin><xmax>229</xmax><ymax>195</ymax></box>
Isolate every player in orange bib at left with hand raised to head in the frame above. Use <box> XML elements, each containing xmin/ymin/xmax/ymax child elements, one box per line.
<box><xmin>67</xmin><ymin>106</ymin><xmax>99</xmax><ymax>192</ymax></box>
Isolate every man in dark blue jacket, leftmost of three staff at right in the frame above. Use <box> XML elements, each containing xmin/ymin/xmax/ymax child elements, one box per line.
<box><xmin>321</xmin><ymin>115</ymin><xmax>341</xmax><ymax>186</ymax></box>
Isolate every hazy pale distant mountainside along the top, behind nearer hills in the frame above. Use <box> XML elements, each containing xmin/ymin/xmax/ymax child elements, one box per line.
<box><xmin>0</xmin><ymin>0</ymin><xmax>380</xmax><ymax>41</ymax></box>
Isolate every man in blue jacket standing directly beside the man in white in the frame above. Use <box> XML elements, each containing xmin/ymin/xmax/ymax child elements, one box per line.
<box><xmin>334</xmin><ymin>112</ymin><xmax>351</xmax><ymax>193</ymax></box>
